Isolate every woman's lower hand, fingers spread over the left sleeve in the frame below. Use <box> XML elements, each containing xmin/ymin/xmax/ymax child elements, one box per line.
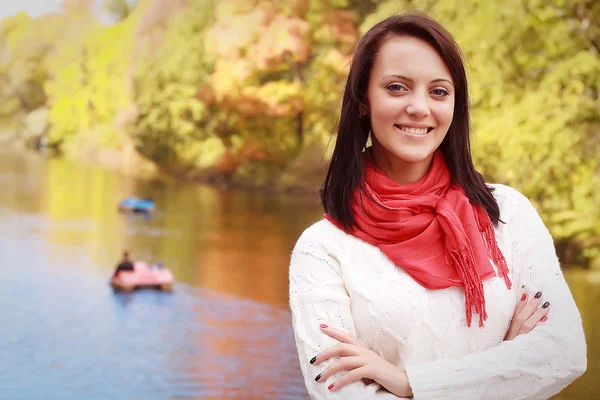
<box><xmin>310</xmin><ymin>324</ymin><xmax>413</xmax><ymax>397</ymax></box>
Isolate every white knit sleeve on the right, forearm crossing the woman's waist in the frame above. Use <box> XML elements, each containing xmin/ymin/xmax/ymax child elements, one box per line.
<box><xmin>406</xmin><ymin>190</ymin><xmax>587</xmax><ymax>400</ymax></box>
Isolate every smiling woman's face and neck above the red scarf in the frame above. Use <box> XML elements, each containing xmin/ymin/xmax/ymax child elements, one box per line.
<box><xmin>367</xmin><ymin>36</ymin><xmax>454</xmax><ymax>183</ymax></box>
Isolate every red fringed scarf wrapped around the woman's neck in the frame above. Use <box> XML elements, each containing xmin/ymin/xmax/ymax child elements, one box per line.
<box><xmin>325</xmin><ymin>151</ymin><xmax>511</xmax><ymax>327</ymax></box>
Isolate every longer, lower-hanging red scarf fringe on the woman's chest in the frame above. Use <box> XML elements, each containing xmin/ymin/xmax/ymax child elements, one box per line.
<box><xmin>449</xmin><ymin>246</ymin><xmax>487</xmax><ymax>328</ymax></box>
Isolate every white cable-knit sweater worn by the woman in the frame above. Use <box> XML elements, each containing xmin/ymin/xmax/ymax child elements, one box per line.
<box><xmin>289</xmin><ymin>185</ymin><xmax>587</xmax><ymax>400</ymax></box>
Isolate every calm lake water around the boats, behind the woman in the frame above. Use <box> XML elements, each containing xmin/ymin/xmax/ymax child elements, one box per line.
<box><xmin>0</xmin><ymin>148</ymin><xmax>600</xmax><ymax>400</ymax></box>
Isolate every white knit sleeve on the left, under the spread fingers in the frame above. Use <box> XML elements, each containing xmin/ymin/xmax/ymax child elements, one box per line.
<box><xmin>289</xmin><ymin>227</ymin><xmax>408</xmax><ymax>400</ymax></box>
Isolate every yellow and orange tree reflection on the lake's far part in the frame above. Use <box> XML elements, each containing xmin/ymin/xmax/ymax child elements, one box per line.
<box><xmin>0</xmin><ymin>149</ymin><xmax>321</xmax><ymax>308</ymax></box>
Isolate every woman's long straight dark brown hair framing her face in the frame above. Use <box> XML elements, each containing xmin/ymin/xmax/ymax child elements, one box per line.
<box><xmin>321</xmin><ymin>12</ymin><xmax>500</xmax><ymax>229</ymax></box>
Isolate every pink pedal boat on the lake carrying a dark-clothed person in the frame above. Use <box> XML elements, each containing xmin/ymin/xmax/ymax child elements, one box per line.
<box><xmin>110</xmin><ymin>261</ymin><xmax>175</xmax><ymax>292</ymax></box>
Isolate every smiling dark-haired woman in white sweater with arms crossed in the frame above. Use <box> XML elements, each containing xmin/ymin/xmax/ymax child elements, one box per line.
<box><xmin>290</xmin><ymin>13</ymin><xmax>586</xmax><ymax>400</ymax></box>
